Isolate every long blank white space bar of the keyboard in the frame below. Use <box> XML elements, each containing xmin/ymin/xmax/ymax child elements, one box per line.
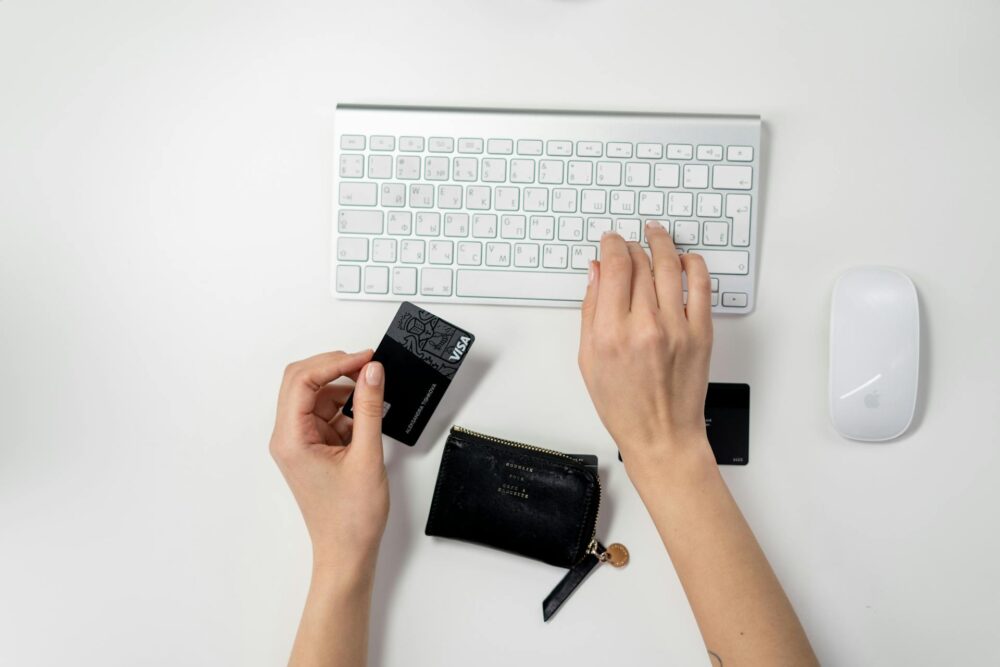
<box><xmin>455</xmin><ymin>269</ymin><xmax>587</xmax><ymax>301</ymax></box>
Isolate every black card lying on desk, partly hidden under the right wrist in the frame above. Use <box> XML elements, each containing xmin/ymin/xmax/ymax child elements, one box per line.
<box><xmin>618</xmin><ymin>382</ymin><xmax>750</xmax><ymax>466</ymax></box>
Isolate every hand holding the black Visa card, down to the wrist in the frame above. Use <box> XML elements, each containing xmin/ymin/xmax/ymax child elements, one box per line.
<box><xmin>270</xmin><ymin>350</ymin><xmax>389</xmax><ymax>573</ymax></box>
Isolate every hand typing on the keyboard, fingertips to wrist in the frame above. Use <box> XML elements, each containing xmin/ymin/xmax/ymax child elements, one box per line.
<box><xmin>579</xmin><ymin>222</ymin><xmax>712</xmax><ymax>482</ymax></box>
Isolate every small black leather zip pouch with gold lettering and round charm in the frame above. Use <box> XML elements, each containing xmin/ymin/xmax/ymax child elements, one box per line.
<box><xmin>425</xmin><ymin>426</ymin><xmax>627</xmax><ymax>620</ymax></box>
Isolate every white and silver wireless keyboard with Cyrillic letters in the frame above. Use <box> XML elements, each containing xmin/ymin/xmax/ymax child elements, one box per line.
<box><xmin>332</xmin><ymin>105</ymin><xmax>760</xmax><ymax>313</ymax></box>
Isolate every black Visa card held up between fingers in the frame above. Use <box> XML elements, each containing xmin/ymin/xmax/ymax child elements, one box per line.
<box><xmin>344</xmin><ymin>301</ymin><xmax>476</xmax><ymax>447</ymax></box>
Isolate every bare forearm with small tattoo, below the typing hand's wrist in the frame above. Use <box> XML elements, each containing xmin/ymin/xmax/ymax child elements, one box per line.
<box><xmin>630</xmin><ymin>442</ymin><xmax>816</xmax><ymax>666</ymax></box>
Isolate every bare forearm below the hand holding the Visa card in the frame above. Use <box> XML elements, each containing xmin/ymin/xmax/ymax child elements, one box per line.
<box><xmin>288</xmin><ymin>564</ymin><xmax>375</xmax><ymax>667</ymax></box>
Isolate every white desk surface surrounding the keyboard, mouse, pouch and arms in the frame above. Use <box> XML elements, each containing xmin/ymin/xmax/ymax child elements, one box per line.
<box><xmin>0</xmin><ymin>0</ymin><xmax>1000</xmax><ymax>667</ymax></box>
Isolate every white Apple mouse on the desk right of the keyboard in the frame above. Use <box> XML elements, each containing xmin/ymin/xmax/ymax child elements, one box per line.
<box><xmin>830</xmin><ymin>266</ymin><xmax>920</xmax><ymax>442</ymax></box>
